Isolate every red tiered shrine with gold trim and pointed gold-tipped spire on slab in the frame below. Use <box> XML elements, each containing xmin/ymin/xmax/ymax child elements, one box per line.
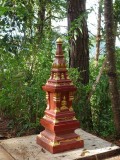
<box><xmin>37</xmin><ymin>38</ymin><xmax>84</xmax><ymax>153</ymax></box>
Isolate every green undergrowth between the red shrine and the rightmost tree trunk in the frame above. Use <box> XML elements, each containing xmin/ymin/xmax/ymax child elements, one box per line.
<box><xmin>69</xmin><ymin>56</ymin><xmax>119</xmax><ymax>137</ymax></box>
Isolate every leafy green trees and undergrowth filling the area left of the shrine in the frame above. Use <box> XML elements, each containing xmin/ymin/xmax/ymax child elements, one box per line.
<box><xmin>0</xmin><ymin>0</ymin><xmax>66</xmax><ymax>135</ymax></box>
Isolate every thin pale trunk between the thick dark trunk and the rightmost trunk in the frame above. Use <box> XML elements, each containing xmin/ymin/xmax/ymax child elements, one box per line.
<box><xmin>95</xmin><ymin>0</ymin><xmax>102</xmax><ymax>66</ymax></box>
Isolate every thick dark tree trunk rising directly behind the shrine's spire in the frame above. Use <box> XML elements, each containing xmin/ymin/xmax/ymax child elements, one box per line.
<box><xmin>68</xmin><ymin>0</ymin><xmax>89</xmax><ymax>85</ymax></box>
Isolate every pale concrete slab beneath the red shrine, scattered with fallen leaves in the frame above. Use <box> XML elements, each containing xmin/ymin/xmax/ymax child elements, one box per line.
<box><xmin>0</xmin><ymin>129</ymin><xmax>120</xmax><ymax>160</ymax></box>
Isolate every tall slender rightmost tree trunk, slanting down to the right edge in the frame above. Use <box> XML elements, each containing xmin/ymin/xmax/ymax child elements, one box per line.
<box><xmin>104</xmin><ymin>0</ymin><xmax>120</xmax><ymax>136</ymax></box>
